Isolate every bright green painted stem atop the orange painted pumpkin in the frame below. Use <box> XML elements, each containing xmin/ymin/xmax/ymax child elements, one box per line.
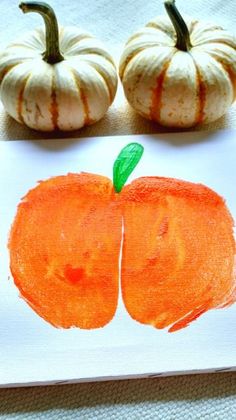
<box><xmin>113</xmin><ymin>143</ymin><xmax>144</xmax><ymax>193</ymax></box>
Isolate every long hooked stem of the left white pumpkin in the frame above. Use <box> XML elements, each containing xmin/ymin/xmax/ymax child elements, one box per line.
<box><xmin>19</xmin><ymin>1</ymin><xmax>64</xmax><ymax>64</ymax></box>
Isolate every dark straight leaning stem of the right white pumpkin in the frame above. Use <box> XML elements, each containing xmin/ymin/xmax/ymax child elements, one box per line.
<box><xmin>164</xmin><ymin>0</ymin><xmax>191</xmax><ymax>51</ymax></box>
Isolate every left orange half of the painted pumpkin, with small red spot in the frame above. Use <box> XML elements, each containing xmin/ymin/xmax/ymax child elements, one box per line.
<box><xmin>9</xmin><ymin>174</ymin><xmax>121</xmax><ymax>329</ymax></box>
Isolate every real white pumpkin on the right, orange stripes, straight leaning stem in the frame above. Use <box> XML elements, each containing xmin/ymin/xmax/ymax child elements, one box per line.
<box><xmin>119</xmin><ymin>0</ymin><xmax>236</xmax><ymax>127</ymax></box>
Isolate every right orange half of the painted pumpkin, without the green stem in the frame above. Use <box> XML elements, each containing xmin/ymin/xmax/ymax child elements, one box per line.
<box><xmin>121</xmin><ymin>177</ymin><xmax>235</xmax><ymax>331</ymax></box>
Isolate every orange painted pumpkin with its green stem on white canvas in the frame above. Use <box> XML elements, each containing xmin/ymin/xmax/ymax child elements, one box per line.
<box><xmin>9</xmin><ymin>143</ymin><xmax>235</xmax><ymax>331</ymax></box>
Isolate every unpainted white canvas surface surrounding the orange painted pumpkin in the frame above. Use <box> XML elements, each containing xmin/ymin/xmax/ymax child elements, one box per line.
<box><xmin>0</xmin><ymin>131</ymin><xmax>236</xmax><ymax>386</ymax></box>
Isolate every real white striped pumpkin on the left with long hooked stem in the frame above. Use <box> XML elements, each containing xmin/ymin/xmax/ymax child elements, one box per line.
<box><xmin>0</xmin><ymin>2</ymin><xmax>117</xmax><ymax>131</ymax></box>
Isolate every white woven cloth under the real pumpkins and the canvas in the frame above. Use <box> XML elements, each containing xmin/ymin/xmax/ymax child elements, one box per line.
<box><xmin>0</xmin><ymin>0</ymin><xmax>236</xmax><ymax>420</ymax></box>
